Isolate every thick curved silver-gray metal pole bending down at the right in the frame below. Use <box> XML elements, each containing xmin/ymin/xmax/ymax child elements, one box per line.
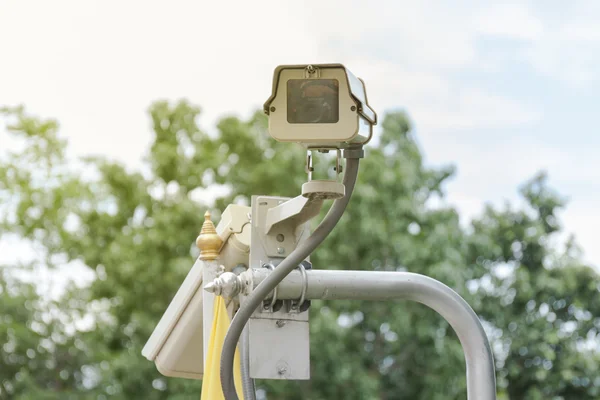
<box><xmin>248</xmin><ymin>269</ymin><xmax>496</xmax><ymax>400</ymax></box>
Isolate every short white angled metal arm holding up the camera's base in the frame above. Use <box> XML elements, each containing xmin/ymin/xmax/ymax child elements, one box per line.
<box><xmin>265</xmin><ymin>196</ymin><xmax>323</xmax><ymax>235</ymax></box>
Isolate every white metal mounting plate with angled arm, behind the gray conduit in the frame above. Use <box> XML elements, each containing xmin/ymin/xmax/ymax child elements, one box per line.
<box><xmin>245</xmin><ymin>196</ymin><xmax>310</xmax><ymax>379</ymax></box>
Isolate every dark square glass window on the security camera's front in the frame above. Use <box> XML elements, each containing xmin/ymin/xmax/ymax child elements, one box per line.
<box><xmin>287</xmin><ymin>79</ymin><xmax>339</xmax><ymax>124</ymax></box>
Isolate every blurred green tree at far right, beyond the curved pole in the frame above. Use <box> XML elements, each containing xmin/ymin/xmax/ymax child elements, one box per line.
<box><xmin>468</xmin><ymin>174</ymin><xmax>600</xmax><ymax>400</ymax></box>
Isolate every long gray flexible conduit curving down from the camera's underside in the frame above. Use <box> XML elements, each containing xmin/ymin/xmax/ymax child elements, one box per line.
<box><xmin>220</xmin><ymin>153</ymin><xmax>359</xmax><ymax>400</ymax></box>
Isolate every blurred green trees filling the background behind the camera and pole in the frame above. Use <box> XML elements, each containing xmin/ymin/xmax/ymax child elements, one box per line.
<box><xmin>0</xmin><ymin>101</ymin><xmax>600</xmax><ymax>400</ymax></box>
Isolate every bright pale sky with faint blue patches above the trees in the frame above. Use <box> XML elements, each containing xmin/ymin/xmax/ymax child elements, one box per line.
<box><xmin>0</xmin><ymin>0</ymin><xmax>600</xmax><ymax>266</ymax></box>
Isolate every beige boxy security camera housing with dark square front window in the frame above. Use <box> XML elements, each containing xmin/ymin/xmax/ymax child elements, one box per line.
<box><xmin>264</xmin><ymin>64</ymin><xmax>377</xmax><ymax>149</ymax></box>
